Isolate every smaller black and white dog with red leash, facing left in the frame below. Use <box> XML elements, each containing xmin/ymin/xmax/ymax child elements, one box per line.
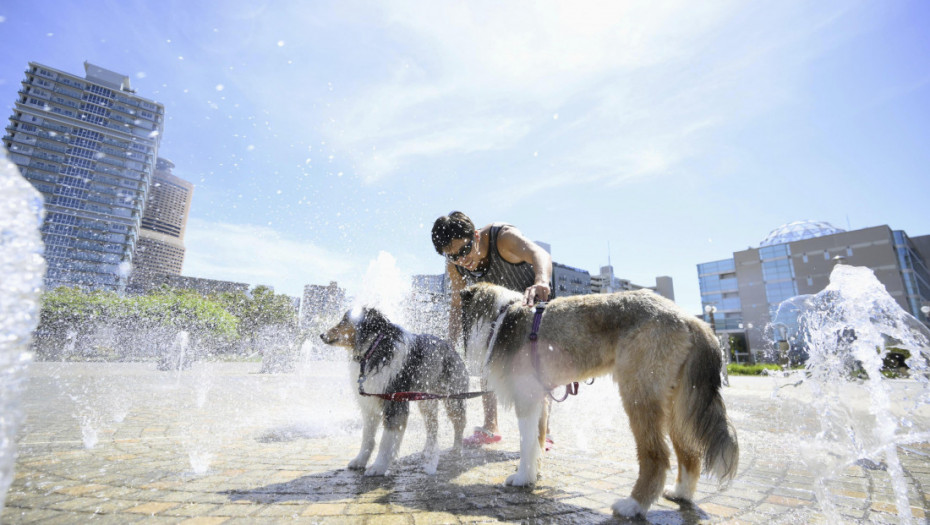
<box><xmin>320</xmin><ymin>308</ymin><xmax>468</xmax><ymax>476</ymax></box>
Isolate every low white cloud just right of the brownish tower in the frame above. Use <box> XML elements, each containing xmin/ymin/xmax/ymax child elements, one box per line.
<box><xmin>183</xmin><ymin>218</ymin><xmax>360</xmax><ymax>296</ymax></box>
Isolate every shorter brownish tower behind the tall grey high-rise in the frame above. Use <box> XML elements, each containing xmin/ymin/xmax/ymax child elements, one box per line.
<box><xmin>130</xmin><ymin>157</ymin><xmax>194</xmax><ymax>286</ymax></box>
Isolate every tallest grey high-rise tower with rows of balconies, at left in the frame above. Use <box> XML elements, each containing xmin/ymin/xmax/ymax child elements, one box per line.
<box><xmin>3</xmin><ymin>62</ymin><xmax>165</xmax><ymax>290</ymax></box>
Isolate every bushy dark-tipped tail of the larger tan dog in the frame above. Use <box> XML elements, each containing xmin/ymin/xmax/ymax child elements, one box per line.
<box><xmin>679</xmin><ymin>319</ymin><xmax>739</xmax><ymax>483</ymax></box>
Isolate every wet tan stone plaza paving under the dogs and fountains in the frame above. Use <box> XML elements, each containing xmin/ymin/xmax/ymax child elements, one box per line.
<box><xmin>0</xmin><ymin>361</ymin><xmax>930</xmax><ymax>525</ymax></box>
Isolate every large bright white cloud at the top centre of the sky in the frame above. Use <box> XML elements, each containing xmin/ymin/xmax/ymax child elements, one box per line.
<box><xmin>330</xmin><ymin>0</ymin><xmax>856</xmax><ymax>187</ymax></box>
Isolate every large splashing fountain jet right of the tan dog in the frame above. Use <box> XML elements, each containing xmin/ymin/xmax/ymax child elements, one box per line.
<box><xmin>774</xmin><ymin>265</ymin><xmax>930</xmax><ymax>523</ymax></box>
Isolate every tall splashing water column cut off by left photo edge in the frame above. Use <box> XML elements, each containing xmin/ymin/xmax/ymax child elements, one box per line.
<box><xmin>0</xmin><ymin>149</ymin><xmax>45</xmax><ymax>514</ymax></box>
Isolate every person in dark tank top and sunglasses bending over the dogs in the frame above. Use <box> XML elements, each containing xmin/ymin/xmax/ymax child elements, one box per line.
<box><xmin>432</xmin><ymin>211</ymin><xmax>552</xmax><ymax>449</ymax></box>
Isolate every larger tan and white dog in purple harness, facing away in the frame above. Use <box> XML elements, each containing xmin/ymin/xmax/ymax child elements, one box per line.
<box><xmin>461</xmin><ymin>283</ymin><xmax>739</xmax><ymax>517</ymax></box>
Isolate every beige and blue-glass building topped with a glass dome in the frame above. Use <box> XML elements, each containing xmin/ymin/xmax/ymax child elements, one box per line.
<box><xmin>697</xmin><ymin>221</ymin><xmax>930</xmax><ymax>361</ymax></box>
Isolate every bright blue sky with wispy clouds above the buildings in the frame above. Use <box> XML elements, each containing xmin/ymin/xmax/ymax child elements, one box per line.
<box><xmin>0</xmin><ymin>0</ymin><xmax>930</xmax><ymax>313</ymax></box>
